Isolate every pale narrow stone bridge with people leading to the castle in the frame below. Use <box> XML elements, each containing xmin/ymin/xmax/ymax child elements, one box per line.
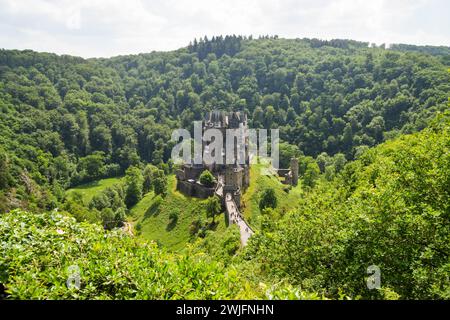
<box><xmin>215</xmin><ymin>176</ymin><xmax>254</xmax><ymax>246</ymax></box>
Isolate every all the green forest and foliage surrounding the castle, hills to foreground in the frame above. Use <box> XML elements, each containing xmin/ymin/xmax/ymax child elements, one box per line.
<box><xmin>0</xmin><ymin>36</ymin><xmax>450</xmax><ymax>299</ymax></box>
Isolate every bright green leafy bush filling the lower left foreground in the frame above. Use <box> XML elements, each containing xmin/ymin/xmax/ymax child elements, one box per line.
<box><xmin>0</xmin><ymin>210</ymin><xmax>250</xmax><ymax>299</ymax></box>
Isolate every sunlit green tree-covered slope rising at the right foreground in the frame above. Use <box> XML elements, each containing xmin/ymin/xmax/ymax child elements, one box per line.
<box><xmin>248</xmin><ymin>114</ymin><xmax>450</xmax><ymax>299</ymax></box>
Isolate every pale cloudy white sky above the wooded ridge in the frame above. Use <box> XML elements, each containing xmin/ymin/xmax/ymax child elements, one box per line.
<box><xmin>0</xmin><ymin>0</ymin><xmax>450</xmax><ymax>58</ymax></box>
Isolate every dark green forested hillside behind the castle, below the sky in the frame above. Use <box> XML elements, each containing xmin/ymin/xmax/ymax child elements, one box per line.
<box><xmin>0</xmin><ymin>37</ymin><xmax>450</xmax><ymax>215</ymax></box>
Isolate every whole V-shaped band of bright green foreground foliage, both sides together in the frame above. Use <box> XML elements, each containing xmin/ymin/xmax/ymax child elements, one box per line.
<box><xmin>0</xmin><ymin>111</ymin><xmax>450</xmax><ymax>299</ymax></box>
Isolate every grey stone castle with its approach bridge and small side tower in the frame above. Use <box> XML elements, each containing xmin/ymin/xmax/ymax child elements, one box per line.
<box><xmin>176</xmin><ymin>110</ymin><xmax>298</xmax><ymax>246</ymax></box>
